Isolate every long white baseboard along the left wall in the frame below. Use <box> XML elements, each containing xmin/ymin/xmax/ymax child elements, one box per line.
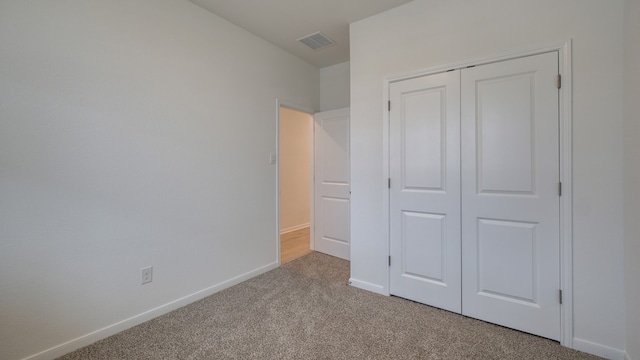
<box><xmin>23</xmin><ymin>262</ymin><xmax>278</xmax><ymax>360</ymax></box>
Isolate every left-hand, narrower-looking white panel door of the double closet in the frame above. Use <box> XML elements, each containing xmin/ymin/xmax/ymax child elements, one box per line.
<box><xmin>390</xmin><ymin>71</ymin><xmax>461</xmax><ymax>313</ymax></box>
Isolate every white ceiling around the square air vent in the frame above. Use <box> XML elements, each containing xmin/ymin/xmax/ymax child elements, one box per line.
<box><xmin>189</xmin><ymin>0</ymin><xmax>412</xmax><ymax>68</ymax></box>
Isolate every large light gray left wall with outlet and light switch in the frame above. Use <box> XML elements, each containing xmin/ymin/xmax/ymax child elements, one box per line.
<box><xmin>0</xmin><ymin>0</ymin><xmax>320</xmax><ymax>360</ymax></box>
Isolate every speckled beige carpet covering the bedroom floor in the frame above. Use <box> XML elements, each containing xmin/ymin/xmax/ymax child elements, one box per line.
<box><xmin>60</xmin><ymin>253</ymin><xmax>596</xmax><ymax>360</ymax></box>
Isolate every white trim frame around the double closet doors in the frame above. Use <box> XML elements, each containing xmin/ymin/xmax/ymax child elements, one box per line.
<box><xmin>381</xmin><ymin>39</ymin><xmax>574</xmax><ymax>348</ymax></box>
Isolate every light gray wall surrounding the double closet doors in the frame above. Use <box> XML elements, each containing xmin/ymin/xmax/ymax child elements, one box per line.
<box><xmin>351</xmin><ymin>0</ymin><xmax>624</xmax><ymax>358</ymax></box>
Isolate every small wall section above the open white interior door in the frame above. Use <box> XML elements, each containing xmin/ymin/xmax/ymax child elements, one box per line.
<box><xmin>320</xmin><ymin>61</ymin><xmax>350</xmax><ymax>111</ymax></box>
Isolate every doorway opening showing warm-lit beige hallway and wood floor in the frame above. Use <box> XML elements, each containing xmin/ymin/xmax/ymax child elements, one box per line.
<box><xmin>278</xmin><ymin>106</ymin><xmax>313</xmax><ymax>264</ymax></box>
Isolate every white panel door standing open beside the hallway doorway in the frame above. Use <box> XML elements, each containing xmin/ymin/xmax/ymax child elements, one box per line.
<box><xmin>313</xmin><ymin>108</ymin><xmax>351</xmax><ymax>260</ymax></box>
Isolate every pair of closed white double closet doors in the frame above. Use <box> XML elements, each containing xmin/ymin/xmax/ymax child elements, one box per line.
<box><xmin>389</xmin><ymin>52</ymin><xmax>560</xmax><ymax>340</ymax></box>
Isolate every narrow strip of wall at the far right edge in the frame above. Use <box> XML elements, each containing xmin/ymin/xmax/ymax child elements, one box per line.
<box><xmin>624</xmin><ymin>0</ymin><xmax>640</xmax><ymax>360</ymax></box>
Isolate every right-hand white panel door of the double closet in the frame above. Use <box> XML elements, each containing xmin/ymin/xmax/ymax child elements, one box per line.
<box><xmin>461</xmin><ymin>52</ymin><xmax>560</xmax><ymax>340</ymax></box>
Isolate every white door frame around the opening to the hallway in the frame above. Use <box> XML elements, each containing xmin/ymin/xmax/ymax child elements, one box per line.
<box><xmin>275</xmin><ymin>98</ymin><xmax>315</xmax><ymax>266</ymax></box>
